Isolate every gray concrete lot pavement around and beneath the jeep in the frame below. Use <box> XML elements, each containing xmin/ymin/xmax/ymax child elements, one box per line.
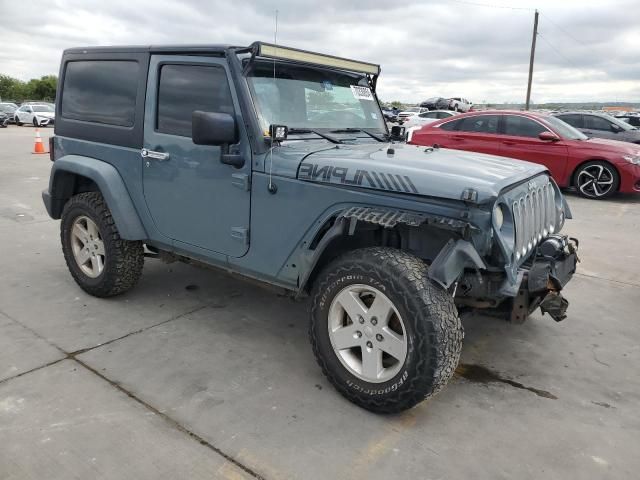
<box><xmin>0</xmin><ymin>125</ymin><xmax>640</xmax><ymax>480</ymax></box>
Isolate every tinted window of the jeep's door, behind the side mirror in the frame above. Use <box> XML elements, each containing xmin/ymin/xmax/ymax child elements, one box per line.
<box><xmin>156</xmin><ymin>65</ymin><xmax>233</xmax><ymax>137</ymax></box>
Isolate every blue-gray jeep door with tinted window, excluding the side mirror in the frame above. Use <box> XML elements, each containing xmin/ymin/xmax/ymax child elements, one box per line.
<box><xmin>141</xmin><ymin>55</ymin><xmax>251</xmax><ymax>257</ymax></box>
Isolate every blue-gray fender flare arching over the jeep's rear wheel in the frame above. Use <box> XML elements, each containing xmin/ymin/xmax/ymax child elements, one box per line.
<box><xmin>42</xmin><ymin>155</ymin><xmax>148</xmax><ymax>240</ymax></box>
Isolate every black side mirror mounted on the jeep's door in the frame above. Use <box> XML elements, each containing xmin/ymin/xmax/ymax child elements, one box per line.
<box><xmin>191</xmin><ymin>110</ymin><xmax>244</xmax><ymax>168</ymax></box>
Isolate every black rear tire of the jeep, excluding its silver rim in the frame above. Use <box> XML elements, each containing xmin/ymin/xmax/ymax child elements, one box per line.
<box><xmin>60</xmin><ymin>192</ymin><xmax>144</xmax><ymax>297</ymax></box>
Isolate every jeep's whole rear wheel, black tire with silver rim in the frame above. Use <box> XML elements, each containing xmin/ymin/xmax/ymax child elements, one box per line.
<box><xmin>60</xmin><ymin>192</ymin><xmax>144</xmax><ymax>297</ymax></box>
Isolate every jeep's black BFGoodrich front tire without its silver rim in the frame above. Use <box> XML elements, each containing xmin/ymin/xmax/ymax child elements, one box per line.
<box><xmin>309</xmin><ymin>247</ymin><xmax>464</xmax><ymax>413</ymax></box>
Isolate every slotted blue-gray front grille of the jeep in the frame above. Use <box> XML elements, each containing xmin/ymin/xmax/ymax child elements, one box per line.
<box><xmin>512</xmin><ymin>182</ymin><xmax>556</xmax><ymax>261</ymax></box>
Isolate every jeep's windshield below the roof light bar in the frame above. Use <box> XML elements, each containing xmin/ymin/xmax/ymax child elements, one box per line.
<box><xmin>247</xmin><ymin>61</ymin><xmax>386</xmax><ymax>132</ymax></box>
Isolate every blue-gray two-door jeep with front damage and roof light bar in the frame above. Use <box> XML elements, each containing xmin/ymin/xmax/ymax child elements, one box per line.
<box><xmin>43</xmin><ymin>43</ymin><xmax>577</xmax><ymax>412</ymax></box>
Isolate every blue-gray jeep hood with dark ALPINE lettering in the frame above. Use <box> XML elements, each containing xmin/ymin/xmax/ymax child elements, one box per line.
<box><xmin>284</xmin><ymin>142</ymin><xmax>546</xmax><ymax>203</ymax></box>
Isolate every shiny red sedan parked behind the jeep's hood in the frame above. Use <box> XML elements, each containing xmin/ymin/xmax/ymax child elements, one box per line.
<box><xmin>409</xmin><ymin>111</ymin><xmax>640</xmax><ymax>199</ymax></box>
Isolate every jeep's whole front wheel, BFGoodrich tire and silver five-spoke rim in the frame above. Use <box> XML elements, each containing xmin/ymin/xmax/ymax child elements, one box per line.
<box><xmin>309</xmin><ymin>247</ymin><xmax>463</xmax><ymax>413</ymax></box>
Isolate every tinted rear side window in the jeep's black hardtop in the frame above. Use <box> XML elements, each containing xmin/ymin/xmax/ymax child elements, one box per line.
<box><xmin>62</xmin><ymin>60</ymin><xmax>140</xmax><ymax>127</ymax></box>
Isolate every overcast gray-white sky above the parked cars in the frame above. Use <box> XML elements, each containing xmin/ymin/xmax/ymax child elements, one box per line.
<box><xmin>0</xmin><ymin>0</ymin><xmax>640</xmax><ymax>103</ymax></box>
